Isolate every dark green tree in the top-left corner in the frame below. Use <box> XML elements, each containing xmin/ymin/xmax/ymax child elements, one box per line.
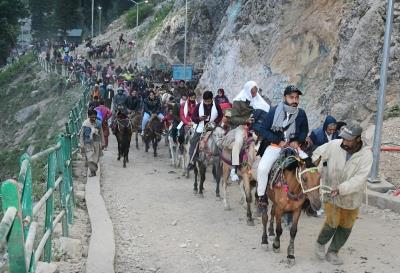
<box><xmin>0</xmin><ymin>0</ymin><xmax>28</xmax><ymax>65</ymax></box>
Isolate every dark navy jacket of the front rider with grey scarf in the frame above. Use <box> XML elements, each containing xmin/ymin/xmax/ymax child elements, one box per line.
<box><xmin>262</xmin><ymin>106</ymin><xmax>308</xmax><ymax>144</ymax></box>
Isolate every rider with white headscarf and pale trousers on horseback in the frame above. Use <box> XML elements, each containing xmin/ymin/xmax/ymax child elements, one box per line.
<box><xmin>230</xmin><ymin>81</ymin><xmax>269</xmax><ymax>182</ymax></box>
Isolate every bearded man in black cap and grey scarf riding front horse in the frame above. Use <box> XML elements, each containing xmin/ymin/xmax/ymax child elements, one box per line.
<box><xmin>257</xmin><ymin>85</ymin><xmax>308</xmax><ymax>210</ymax></box>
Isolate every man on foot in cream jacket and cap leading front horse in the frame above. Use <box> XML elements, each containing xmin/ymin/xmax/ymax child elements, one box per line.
<box><xmin>313</xmin><ymin>123</ymin><xmax>372</xmax><ymax>265</ymax></box>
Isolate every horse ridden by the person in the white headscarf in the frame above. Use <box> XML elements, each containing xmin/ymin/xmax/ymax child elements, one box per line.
<box><xmin>221</xmin><ymin>132</ymin><xmax>258</xmax><ymax>223</ymax></box>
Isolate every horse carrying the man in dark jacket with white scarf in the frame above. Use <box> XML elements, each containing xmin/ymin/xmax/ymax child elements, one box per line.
<box><xmin>193</xmin><ymin>122</ymin><xmax>225</xmax><ymax>198</ymax></box>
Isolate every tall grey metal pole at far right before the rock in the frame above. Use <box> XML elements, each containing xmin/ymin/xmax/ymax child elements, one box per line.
<box><xmin>368</xmin><ymin>0</ymin><xmax>393</xmax><ymax>183</ymax></box>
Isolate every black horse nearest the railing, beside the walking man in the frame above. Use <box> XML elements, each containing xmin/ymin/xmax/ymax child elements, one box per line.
<box><xmin>113</xmin><ymin>112</ymin><xmax>135</xmax><ymax>168</ymax></box>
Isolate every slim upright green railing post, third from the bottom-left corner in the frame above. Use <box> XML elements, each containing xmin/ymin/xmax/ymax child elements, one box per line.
<box><xmin>44</xmin><ymin>152</ymin><xmax>57</xmax><ymax>263</ymax></box>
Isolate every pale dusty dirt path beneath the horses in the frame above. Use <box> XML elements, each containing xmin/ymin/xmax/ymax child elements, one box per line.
<box><xmin>102</xmin><ymin>136</ymin><xmax>400</xmax><ymax>273</ymax></box>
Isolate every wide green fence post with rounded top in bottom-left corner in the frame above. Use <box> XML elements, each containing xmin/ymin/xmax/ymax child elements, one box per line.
<box><xmin>1</xmin><ymin>180</ymin><xmax>28</xmax><ymax>273</ymax></box>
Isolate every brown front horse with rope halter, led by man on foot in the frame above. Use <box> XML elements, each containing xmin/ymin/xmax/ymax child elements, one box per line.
<box><xmin>261</xmin><ymin>148</ymin><xmax>321</xmax><ymax>265</ymax></box>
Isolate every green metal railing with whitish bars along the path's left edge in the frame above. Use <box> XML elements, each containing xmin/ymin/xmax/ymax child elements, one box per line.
<box><xmin>0</xmin><ymin>87</ymin><xmax>89</xmax><ymax>273</ymax></box>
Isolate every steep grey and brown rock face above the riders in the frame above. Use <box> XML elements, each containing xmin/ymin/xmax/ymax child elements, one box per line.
<box><xmin>137</xmin><ymin>0</ymin><xmax>400</xmax><ymax>124</ymax></box>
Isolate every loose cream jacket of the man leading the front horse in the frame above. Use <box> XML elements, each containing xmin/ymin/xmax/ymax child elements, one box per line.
<box><xmin>312</xmin><ymin>139</ymin><xmax>372</xmax><ymax>209</ymax></box>
